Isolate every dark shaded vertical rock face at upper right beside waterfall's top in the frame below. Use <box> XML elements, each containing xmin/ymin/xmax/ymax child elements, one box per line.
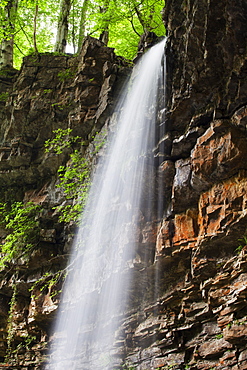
<box><xmin>164</xmin><ymin>0</ymin><xmax>246</xmax><ymax>134</ymax></box>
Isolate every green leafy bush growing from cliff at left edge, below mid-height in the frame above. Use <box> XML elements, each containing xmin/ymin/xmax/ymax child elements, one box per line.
<box><xmin>0</xmin><ymin>202</ymin><xmax>40</xmax><ymax>268</ymax></box>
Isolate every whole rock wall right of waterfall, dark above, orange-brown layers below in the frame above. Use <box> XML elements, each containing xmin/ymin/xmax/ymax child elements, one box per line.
<box><xmin>120</xmin><ymin>0</ymin><xmax>247</xmax><ymax>370</ymax></box>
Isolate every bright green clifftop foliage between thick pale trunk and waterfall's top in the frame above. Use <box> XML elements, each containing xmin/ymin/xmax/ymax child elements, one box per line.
<box><xmin>74</xmin><ymin>0</ymin><xmax>165</xmax><ymax>59</ymax></box>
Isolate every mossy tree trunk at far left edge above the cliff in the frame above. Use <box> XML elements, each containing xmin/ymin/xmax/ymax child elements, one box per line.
<box><xmin>0</xmin><ymin>0</ymin><xmax>18</xmax><ymax>69</ymax></box>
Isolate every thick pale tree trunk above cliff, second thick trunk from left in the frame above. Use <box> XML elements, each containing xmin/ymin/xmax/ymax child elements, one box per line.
<box><xmin>54</xmin><ymin>0</ymin><xmax>71</xmax><ymax>53</ymax></box>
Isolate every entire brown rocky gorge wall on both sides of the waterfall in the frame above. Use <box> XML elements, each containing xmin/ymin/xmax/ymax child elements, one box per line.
<box><xmin>0</xmin><ymin>0</ymin><xmax>247</xmax><ymax>370</ymax></box>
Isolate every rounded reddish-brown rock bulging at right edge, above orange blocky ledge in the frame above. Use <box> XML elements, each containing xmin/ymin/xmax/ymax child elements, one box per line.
<box><xmin>191</xmin><ymin>120</ymin><xmax>247</xmax><ymax>190</ymax></box>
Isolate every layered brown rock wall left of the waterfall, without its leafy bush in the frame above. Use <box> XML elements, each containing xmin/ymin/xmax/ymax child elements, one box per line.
<box><xmin>0</xmin><ymin>37</ymin><xmax>130</xmax><ymax>369</ymax></box>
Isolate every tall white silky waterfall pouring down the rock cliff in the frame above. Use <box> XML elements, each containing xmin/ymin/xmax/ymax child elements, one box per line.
<box><xmin>49</xmin><ymin>40</ymin><xmax>165</xmax><ymax>370</ymax></box>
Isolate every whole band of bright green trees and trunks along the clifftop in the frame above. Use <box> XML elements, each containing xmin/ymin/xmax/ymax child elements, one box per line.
<box><xmin>0</xmin><ymin>0</ymin><xmax>165</xmax><ymax>68</ymax></box>
